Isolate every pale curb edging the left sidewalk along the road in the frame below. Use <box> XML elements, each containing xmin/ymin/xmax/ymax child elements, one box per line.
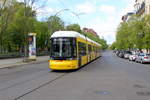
<box><xmin>0</xmin><ymin>60</ymin><xmax>48</xmax><ymax>69</ymax></box>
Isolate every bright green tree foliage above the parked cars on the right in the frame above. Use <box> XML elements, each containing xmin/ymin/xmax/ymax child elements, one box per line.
<box><xmin>113</xmin><ymin>15</ymin><xmax>150</xmax><ymax>49</ymax></box>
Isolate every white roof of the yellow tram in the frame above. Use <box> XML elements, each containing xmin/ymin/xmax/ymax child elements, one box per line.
<box><xmin>51</xmin><ymin>31</ymin><xmax>100</xmax><ymax>46</ymax></box>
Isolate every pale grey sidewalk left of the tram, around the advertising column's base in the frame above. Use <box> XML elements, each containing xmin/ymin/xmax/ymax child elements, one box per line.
<box><xmin>0</xmin><ymin>56</ymin><xmax>49</xmax><ymax>69</ymax></box>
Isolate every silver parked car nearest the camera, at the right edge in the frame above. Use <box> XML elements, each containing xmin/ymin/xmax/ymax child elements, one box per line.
<box><xmin>135</xmin><ymin>53</ymin><xmax>150</xmax><ymax>64</ymax></box>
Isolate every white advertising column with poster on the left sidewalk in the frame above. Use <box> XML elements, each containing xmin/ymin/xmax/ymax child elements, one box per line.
<box><xmin>28</xmin><ymin>33</ymin><xmax>36</xmax><ymax>60</ymax></box>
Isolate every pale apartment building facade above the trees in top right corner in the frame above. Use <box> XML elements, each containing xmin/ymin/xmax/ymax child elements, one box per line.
<box><xmin>134</xmin><ymin>0</ymin><xmax>150</xmax><ymax>16</ymax></box>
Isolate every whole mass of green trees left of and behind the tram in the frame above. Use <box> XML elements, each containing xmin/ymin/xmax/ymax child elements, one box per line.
<box><xmin>0</xmin><ymin>0</ymin><xmax>107</xmax><ymax>53</ymax></box>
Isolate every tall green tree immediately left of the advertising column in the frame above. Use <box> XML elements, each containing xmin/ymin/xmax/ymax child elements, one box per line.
<box><xmin>8</xmin><ymin>2</ymin><xmax>36</xmax><ymax>55</ymax></box>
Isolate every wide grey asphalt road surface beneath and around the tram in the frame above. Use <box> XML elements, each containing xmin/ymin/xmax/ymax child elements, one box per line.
<box><xmin>0</xmin><ymin>51</ymin><xmax>150</xmax><ymax>100</ymax></box>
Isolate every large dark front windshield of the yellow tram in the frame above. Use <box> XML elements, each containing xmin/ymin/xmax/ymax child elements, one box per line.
<box><xmin>51</xmin><ymin>38</ymin><xmax>76</xmax><ymax>58</ymax></box>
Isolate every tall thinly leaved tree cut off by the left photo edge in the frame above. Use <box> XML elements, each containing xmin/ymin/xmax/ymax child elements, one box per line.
<box><xmin>0</xmin><ymin>0</ymin><xmax>14</xmax><ymax>52</ymax></box>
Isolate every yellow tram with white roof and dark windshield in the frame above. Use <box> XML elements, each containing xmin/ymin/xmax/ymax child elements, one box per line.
<box><xmin>49</xmin><ymin>31</ymin><xmax>101</xmax><ymax>70</ymax></box>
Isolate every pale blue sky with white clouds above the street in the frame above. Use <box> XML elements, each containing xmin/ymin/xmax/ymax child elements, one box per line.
<box><xmin>34</xmin><ymin>0</ymin><xmax>135</xmax><ymax>44</ymax></box>
